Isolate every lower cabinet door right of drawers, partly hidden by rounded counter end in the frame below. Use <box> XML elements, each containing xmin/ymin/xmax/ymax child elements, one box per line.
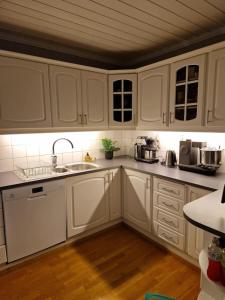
<box><xmin>187</xmin><ymin>186</ymin><xmax>210</xmax><ymax>259</ymax></box>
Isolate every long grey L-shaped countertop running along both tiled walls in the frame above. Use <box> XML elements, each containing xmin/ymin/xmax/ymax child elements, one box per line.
<box><xmin>0</xmin><ymin>156</ymin><xmax>225</xmax><ymax>191</ymax></box>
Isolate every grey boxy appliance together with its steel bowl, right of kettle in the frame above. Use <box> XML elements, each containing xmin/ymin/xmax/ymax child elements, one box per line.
<box><xmin>178</xmin><ymin>140</ymin><xmax>222</xmax><ymax>175</ymax></box>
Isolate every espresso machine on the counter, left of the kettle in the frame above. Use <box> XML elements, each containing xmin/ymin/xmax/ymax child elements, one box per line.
<box><xmin>134</xmin><ymin>136</ymin><xmax>159</xmax><ymax>164</ymax></box>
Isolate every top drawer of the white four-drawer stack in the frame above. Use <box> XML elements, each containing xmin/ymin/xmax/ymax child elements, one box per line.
<box><xmin>154</xmin><ymin>177</ymin><xmax>185</xmax><ymax>201</ymax></box>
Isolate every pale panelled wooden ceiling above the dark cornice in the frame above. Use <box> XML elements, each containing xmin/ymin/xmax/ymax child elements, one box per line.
<box><xmin>0</xmin><ymin>0</ymin><xmax>225</xmax><ymax>66</ymax></box>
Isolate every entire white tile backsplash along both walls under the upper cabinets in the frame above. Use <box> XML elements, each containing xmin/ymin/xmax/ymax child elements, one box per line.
<box><xmin>0</xmin><ymin>130</ymin><xmax>225</xmax><ymax>172</ymax></box>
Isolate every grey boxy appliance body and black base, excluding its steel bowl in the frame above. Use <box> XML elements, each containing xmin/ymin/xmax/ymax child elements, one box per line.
<box><xmin>178</xmin><ymin>140</ymin><xmax>218</xmax><ymax>175</ymax></box>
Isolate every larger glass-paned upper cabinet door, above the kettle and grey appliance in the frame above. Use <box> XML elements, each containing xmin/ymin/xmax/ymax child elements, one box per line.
<box><xmin>169</xmin><ymin>55</ymin><xmax>205</xmax><ymax>127</ymax></box>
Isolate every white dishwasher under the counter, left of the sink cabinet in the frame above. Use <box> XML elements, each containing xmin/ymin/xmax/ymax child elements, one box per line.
<box><xmin>2</xmin><ymin>180</ymin><xmax>66</xmax><ymax>262</ymax></box>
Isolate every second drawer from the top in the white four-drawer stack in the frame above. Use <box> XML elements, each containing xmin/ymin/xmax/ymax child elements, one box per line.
<box><xmin>153</xmin><ymin>192</ymin><xmax>184</xmax><ymax>216</ymax></box>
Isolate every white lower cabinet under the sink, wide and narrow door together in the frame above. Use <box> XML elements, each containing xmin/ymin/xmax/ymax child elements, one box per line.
<box><xmin>66</xmin><ymin>169</ymin><xmax>121</xmax><ymax>237</ymax></box>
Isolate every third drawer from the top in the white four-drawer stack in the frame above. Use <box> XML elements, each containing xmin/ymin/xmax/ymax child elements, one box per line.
<box><xmin>153</xmin><ymin>207</ymin><xmax>185</xmax><ymax>234</ymax></box>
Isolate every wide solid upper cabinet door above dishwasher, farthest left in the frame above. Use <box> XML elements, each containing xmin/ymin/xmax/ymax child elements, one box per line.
<box><xmin>0</xmin><ymin>57</ymin><xmax>51</xmax><ymax>128</ymax></box>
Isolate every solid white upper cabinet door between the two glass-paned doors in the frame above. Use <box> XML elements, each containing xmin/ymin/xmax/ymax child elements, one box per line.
<box><xmin>138</xmin><ymin>66</ymin><xmax>169</xmax><ymax>127</ymax></box>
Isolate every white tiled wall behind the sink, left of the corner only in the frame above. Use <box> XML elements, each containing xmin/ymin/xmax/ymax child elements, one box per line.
<box><xmin>0</xmin><ymin>130</ymin><xmax>125</xmax><ymax>172</ymax></box>
